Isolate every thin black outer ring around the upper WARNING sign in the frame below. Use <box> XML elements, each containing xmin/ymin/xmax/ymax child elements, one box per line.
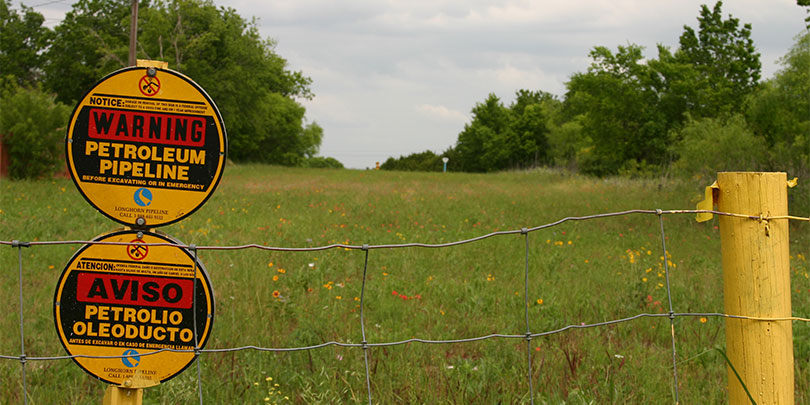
<box><xmin>65</xmin><ymin>66</ymin><xmax>228</xmax><ymax>229</ymax></box>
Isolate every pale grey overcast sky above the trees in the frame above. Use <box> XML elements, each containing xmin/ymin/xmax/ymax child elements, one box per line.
<box><xmin>28</xmin><ymin>0</ymin><xmax>805</xmax><ymax>168</ymax></box>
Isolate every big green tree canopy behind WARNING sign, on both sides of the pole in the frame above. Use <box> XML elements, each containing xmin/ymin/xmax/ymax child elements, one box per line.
<box><xmin>42</xmin><ymin>0</ymin><xmax>323</xmax><ymax>165</ymax></box>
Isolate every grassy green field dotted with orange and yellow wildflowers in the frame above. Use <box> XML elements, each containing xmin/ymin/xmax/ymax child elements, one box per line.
<box><xmin>0</xmin><ymin>165</ymin><xmax>810</xmax><ymax>404</ymax></box>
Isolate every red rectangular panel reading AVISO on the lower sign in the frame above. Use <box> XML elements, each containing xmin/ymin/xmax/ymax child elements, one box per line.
<box><xmin>76</xmin><ymin>272</ymin><xmax>194</xmax><ymax>308</ymax></box>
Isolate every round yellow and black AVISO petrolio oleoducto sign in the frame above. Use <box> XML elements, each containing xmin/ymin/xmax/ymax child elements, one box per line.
<box><xmin>54</xmin><ymin>231</ymin><xmax>214</xmax><ymax>388</ymax></box>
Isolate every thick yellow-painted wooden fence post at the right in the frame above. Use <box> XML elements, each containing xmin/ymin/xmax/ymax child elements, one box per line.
<box><xmin>717</xmin><ymin>172</ymin><xmax>794</xmax><ymax>404</ymax></box>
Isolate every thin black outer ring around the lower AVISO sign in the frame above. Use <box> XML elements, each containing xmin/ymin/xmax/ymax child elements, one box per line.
<box><xmin>53</xmin><ymin>230</ymin><xmax>216</xmax><ymax>385</ymax></box>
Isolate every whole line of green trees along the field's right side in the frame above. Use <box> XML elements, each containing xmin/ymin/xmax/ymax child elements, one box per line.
<box><xmin>381</xmin><ymin>0</ymin><xmax>810</xmax><ymax>192</ymax></box>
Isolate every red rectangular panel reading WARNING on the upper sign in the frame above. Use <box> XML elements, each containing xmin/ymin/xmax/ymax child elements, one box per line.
<box><xmin>87</xmin><ymin>108</ymin><xmax>205</xmax><ymax>147</ymax></box>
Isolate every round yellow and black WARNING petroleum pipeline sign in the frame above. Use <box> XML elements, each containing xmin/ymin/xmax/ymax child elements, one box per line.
<box><xmin>66</xmin><ymin>67</ymin><xmax>227</xmax><ymax>228</ymax></box>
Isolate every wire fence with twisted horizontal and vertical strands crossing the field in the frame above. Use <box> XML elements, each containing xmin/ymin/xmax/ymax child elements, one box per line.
<box><xmin>0</xmin><ymin>209</ymin><xmax>810</xmax><ymax>404</ymax></box>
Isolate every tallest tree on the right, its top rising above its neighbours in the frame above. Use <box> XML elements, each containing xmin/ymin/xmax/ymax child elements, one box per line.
<box><xmin>675</xmin><ymin>1</ymin><xmax>761</xmax><ymax>117</ymax></box>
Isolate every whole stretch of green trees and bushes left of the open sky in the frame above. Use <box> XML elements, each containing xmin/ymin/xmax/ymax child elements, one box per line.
<box><xmin>0</xmin><ymin>0</ymin><xmax>342</xmax><ymax>177</ymax></box>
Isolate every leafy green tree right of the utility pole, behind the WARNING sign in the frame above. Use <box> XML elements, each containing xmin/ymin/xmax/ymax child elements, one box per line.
<box><xmin>138</xmin><ymin>0</ymin><xmax>323</xmax><ymax>166</ymax></box>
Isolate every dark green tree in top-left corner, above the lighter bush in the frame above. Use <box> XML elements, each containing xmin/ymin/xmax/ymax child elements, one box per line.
<box><xmin>0</xmin><ymin>0</ymin><xmax>53</xmax><ymax>86</ymax></box>
